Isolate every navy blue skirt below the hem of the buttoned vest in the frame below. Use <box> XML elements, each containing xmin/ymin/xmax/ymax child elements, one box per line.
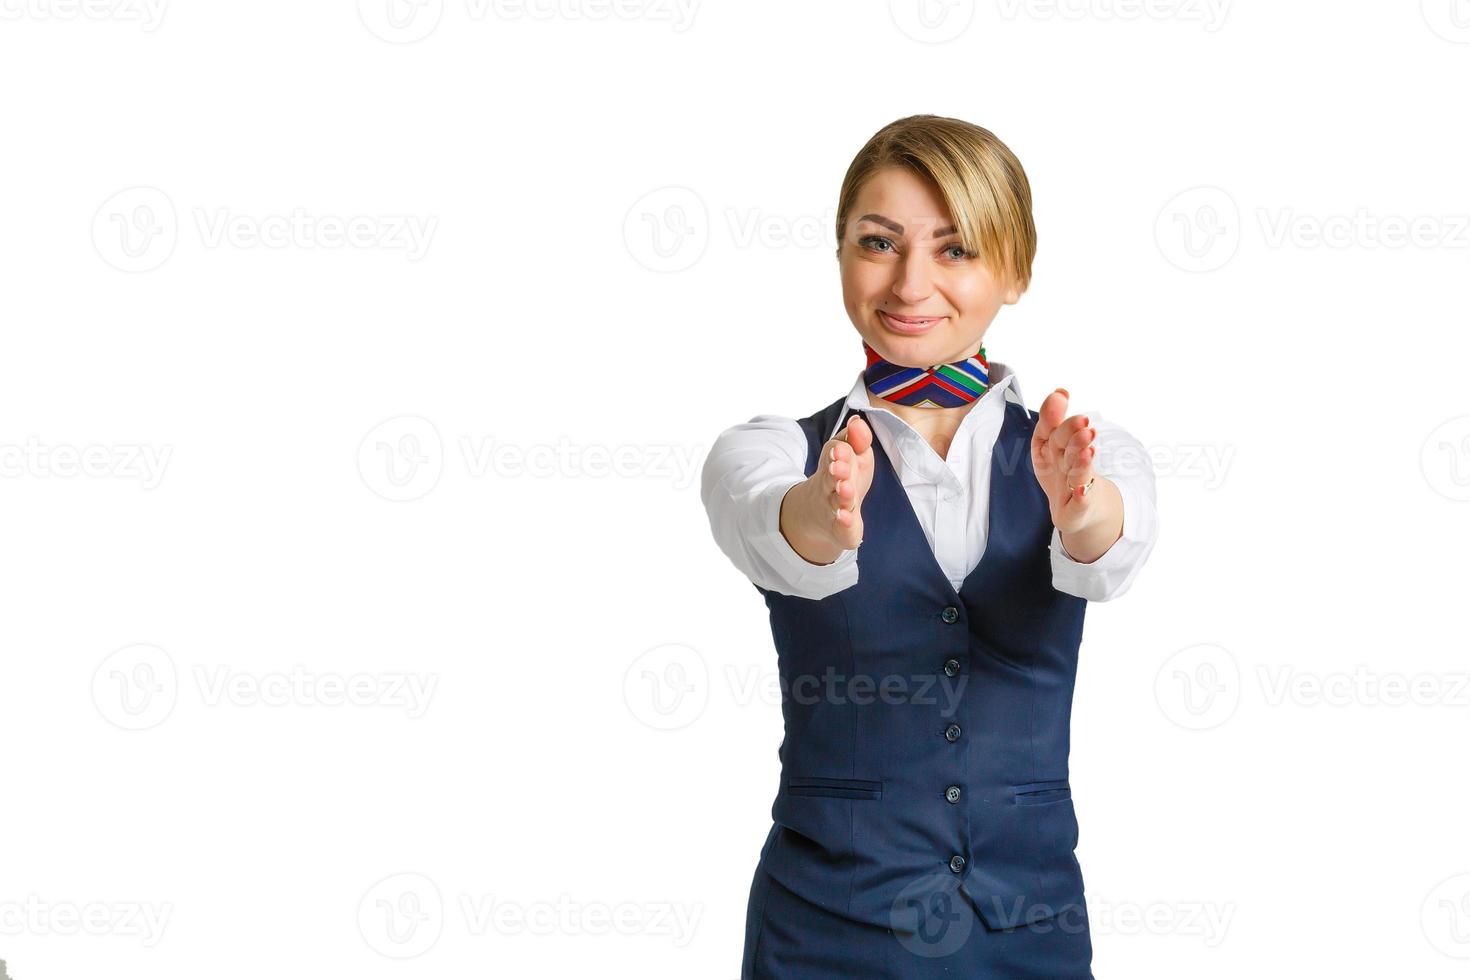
<box><xmin>739</xmin><ymin>864</ymin><xmax>1094</xmax><ymax>980</ymax></box>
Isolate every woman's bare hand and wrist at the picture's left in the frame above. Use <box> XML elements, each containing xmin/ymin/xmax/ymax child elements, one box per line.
<box><xmin>781</xmin><ymin>414</ymin><xmax>873</xmax><ymax>564</ymax></box>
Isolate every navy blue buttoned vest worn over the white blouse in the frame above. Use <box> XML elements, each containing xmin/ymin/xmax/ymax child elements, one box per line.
<box><xmin>757</xmin><ymin>397</ymin><xmax>1086</xmax><ymax>929</ymax></box>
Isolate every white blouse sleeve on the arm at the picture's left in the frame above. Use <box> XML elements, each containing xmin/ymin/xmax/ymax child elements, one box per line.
<box><xmin>700</xmin><ymin>414</ymin><xmax>858</xmax><ymax>599</ymax></box>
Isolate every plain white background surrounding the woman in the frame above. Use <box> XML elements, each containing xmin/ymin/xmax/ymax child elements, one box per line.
<box><xmin>0</xmin><ymin>0</ymin><xmax>1470</xmax><ymax>980</ymax></box>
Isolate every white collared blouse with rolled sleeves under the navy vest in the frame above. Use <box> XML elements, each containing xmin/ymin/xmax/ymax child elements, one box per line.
<box><xmin>700</xmin><ymin>361</ymin><xmax>1158</xmax><ymax>602</ymax></box>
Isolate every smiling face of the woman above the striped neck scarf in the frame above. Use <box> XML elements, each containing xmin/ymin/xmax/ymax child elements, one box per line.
<box><xmin>838</xmin><ymin>167</ymin><xmax>1020</xmax><ymax>367</ymax></box>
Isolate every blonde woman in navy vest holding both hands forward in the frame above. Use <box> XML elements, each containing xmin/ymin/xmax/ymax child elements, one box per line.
<box><xmin>701</xmin><ymin>116</ymin><xmax>1157</xmax><ymax>980</ymax></box>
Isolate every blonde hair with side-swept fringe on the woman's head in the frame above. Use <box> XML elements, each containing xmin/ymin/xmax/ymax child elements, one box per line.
<box><xmin>836</xmin><ymin>115</ymin><xmax>1036</xmax><ymax>292</ymax></box>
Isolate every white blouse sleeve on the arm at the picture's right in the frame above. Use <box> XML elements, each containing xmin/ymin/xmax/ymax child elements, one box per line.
<box><xmin>1051</xmin><ymin>411</ymin><xmax>1158</xmax><ymax>602</ymax></box>
